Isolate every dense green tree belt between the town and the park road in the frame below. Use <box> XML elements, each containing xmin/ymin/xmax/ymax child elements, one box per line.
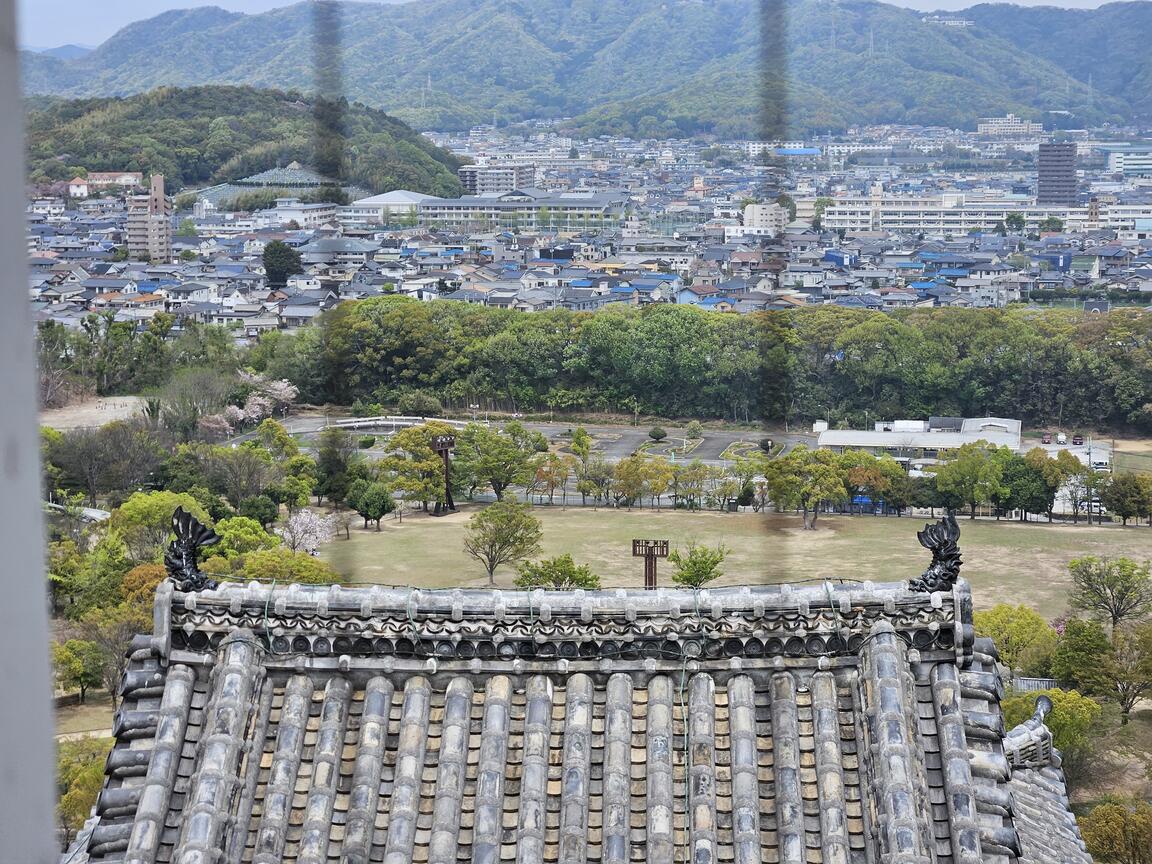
<box><xmin>39</xmin><ymin>296</ymin><xmax>1152</xmax><ymax>432</ymax></box>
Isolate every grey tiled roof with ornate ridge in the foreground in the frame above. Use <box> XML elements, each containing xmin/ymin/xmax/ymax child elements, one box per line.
<box><xmin>70</xmin><ymin>582</ymin><xmax>1081</xmax><ymax>864</ymax></box>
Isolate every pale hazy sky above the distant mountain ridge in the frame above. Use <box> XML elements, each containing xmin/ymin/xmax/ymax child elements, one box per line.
<box><xmin>20</xmin><ymin>0</ymin><xmax>1115</xmax><ymax>48</ymax></box>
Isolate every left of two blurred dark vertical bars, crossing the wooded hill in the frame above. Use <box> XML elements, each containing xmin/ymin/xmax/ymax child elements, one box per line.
<box><xmin>312</xmin><ymin>0</ymin><xmax>348</xmax><ymax>182</ymax></box>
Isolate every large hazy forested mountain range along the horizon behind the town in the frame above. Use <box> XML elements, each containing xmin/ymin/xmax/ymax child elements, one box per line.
<box><xmin>15</xmin><ymin>0</ymin><xmax>1152</xmax><ymax>135</ymax></box>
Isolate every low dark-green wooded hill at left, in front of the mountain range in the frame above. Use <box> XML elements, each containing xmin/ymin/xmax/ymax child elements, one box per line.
<box><xmin>26</xmin><ymin>86</ymin><xmax>460</xmax><ymax>196</ymax></box>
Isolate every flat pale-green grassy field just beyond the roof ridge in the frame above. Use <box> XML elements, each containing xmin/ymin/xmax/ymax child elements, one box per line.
<box><xmin>321</xmin><ymin>507</ymin><xmax>1152</xmax><ymax>617</ymax></box>
